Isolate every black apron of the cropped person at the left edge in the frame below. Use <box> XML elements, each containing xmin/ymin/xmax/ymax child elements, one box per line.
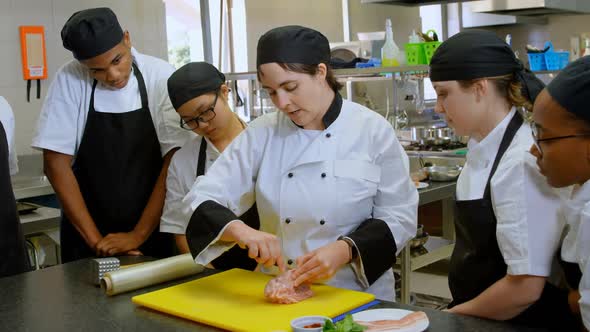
<box><xmin>0</xmin><ymin>122</ymin><xmax>31</xmax><ymax>277</ymax></box>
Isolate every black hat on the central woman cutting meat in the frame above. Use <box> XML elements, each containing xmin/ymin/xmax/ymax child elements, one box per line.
<box><xmin>256</xmin><ymin>25</ymin><xmax>330</xmax><ymax>67</ymax></box>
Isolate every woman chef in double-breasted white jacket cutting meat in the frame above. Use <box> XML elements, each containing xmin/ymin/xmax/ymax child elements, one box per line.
<box><xmin>184</xmin><ymin>26</ymin><xmax>418</xmax><ymax>300</ymax></box>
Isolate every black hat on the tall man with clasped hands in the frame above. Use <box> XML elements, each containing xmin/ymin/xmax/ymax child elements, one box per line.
<box><xmin>61</xmin><ymin>8</ymin><xmax>123</xmax><ymax>60</ymax></box>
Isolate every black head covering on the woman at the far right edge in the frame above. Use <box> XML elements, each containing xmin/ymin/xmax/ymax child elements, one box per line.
<box><xmin>547</xmin><ymin>56</ymin><xmax>590</xmax><ymax>121</ymax></box>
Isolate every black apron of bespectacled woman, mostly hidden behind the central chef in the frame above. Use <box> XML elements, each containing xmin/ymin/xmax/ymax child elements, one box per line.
<box><xmin>197</xmin><ymin>137</ymin><xmax>260</xmax><ymax>271</ymax></box>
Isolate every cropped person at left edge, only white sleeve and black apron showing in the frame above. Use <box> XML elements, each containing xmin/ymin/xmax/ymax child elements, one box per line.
<box><xmin>0</xmin><ymin>97</ymin><xmax>31</xmax><ymax>278</ymax></box>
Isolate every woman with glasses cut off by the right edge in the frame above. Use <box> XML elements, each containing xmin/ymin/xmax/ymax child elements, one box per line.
<box><xmin>531</xmin><ymin>56</ymin><xmax>590</xmax><ymax>331</ymax></box>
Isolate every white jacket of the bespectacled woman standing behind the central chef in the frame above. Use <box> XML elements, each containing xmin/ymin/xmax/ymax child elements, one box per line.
<box><xmin>160</xmin><ymin>136</ymin><xmax>219</xmax><ymax>234</ymax></box>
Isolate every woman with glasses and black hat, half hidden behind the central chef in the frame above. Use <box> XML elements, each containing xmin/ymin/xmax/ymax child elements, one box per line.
<box><xmin>160</xmin><ymin>62</ymin><xmax>259</xmax><ymax>270</ymax></box>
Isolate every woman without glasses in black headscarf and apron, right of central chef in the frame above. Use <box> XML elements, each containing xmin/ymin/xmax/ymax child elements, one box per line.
<box><xmin>430</xmin><ymin>30</ymin><xmax>580</xmax><ymax>331</ymax></box>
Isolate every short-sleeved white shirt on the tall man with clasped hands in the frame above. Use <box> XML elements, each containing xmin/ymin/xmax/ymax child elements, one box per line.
<box><xmin>32</xmin><ymin>48</ymin><xmax>190</xmax><ymax>156</ymax></box>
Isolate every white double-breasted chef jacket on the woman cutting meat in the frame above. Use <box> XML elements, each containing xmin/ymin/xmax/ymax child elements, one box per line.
<box><xmin>183</xmin><ymin>100</ymin><xmax>418</xmax><ymax>300</ymax></box>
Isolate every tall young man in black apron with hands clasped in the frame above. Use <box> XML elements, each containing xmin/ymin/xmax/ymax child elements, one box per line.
<box><xmin>33</xmin><ymin>8</ymin><xmax>187</xmax><ymax>262</ymax></box>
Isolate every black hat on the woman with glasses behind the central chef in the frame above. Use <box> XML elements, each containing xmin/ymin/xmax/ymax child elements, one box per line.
<box><xmin>168</xmin><ymin>62</ymin><xmax>225</xmax><ymax>109</ymax></box>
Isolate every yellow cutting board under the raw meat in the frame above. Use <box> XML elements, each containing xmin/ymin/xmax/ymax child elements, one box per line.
<box><xmin>132</xmin><ymin>269</ymin><xmax>375</xmax><ymax>332</ymax></box>
